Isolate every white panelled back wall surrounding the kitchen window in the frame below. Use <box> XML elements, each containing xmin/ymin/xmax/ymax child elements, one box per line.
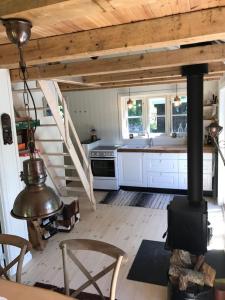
<box><xmin>64</xmin><ymin>81</ymin><xmax>218</xmax><ymax>145</ymax></box>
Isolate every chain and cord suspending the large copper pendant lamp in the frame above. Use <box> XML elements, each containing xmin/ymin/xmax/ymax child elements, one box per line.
<box><xmin>18</xmin><ymin>46</ymin><xmax>37</xmax><ymax>157</ymax></box>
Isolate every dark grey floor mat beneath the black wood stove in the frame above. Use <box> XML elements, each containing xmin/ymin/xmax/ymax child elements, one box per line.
<box><xmin>127</xmin><ymin>240</ymin><xmax>225</xmax><ymax>286</ymax></box>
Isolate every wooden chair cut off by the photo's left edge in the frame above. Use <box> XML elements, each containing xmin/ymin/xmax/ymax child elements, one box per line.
<box><xmin>0</xmin><ymin>234</ymin><xmax>32</xmax><ymax>283</ymax></box>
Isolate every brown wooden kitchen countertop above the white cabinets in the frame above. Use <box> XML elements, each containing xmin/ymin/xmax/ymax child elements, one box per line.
<box><xmin>117</xmin><ymin>145</ymin><xmax>214</xmax><ymax>153</ymax></box>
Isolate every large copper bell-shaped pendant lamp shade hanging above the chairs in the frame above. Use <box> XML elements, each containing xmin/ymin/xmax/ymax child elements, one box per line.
<box><xmin>11</xmin><ymin>158</ymin><xmax>63</xmax><ymax>220</ymax></box>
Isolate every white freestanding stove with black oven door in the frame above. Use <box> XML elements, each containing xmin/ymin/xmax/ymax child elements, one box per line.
<box><xmin>89</xmin><ymin>146</ymin><xmax>119</xmax><ymax>190</ymax></box>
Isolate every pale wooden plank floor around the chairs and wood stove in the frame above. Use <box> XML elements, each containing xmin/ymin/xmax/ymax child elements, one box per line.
<box><xmin>22</xmin><ymin>193</ymin><xmax>225</xmax><ymax>300</ymax></box>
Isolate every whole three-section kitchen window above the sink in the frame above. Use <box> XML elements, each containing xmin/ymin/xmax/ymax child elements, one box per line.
<box><xmin>121</xmin><ymin>94</ymin><xmax>187</xmax><ymax>138</ymax></box>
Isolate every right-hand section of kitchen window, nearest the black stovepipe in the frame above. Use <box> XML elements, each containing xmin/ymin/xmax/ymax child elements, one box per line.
<box><xmin>171</xmin><ymin>96</ymin><xmax>187</xmax><ymax>132</ymax></box>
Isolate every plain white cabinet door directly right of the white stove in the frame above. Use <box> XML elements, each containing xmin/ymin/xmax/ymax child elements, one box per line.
<box><xmin>118</xmin><ymin>152</ymin><xmax>144</xmax><ymax>187</ymax></box>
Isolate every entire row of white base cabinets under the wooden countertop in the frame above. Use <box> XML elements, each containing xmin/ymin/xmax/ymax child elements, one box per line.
<box><xmin>118</xmin><ymin>152</ymin><xmax>212</xmax><ymax>191</ymax></box>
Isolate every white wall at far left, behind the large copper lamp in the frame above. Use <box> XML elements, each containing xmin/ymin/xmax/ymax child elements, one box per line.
<box><xmin>0</xmin><ymin>69</ymin><xmax>31</xmax><ymax>268</ymax></box>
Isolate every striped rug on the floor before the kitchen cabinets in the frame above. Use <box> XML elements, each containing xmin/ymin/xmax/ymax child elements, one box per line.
<box><xmin>100</xmin><ymin>189</ymin><xmax>174</xmax><ymax>209</ymax></box>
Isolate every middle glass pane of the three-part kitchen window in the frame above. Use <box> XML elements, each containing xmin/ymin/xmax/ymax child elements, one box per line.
<box><xmin>149</xmin><ymin>98</ymin><xmax>166</xmax><ymax>133</ymax></box>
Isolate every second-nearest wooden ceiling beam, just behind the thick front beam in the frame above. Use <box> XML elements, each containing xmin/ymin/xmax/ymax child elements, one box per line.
<box><xmin>10</xmin><ymin>45</ymin><xmax>225</xmax><ymax>82</ymax></box>
